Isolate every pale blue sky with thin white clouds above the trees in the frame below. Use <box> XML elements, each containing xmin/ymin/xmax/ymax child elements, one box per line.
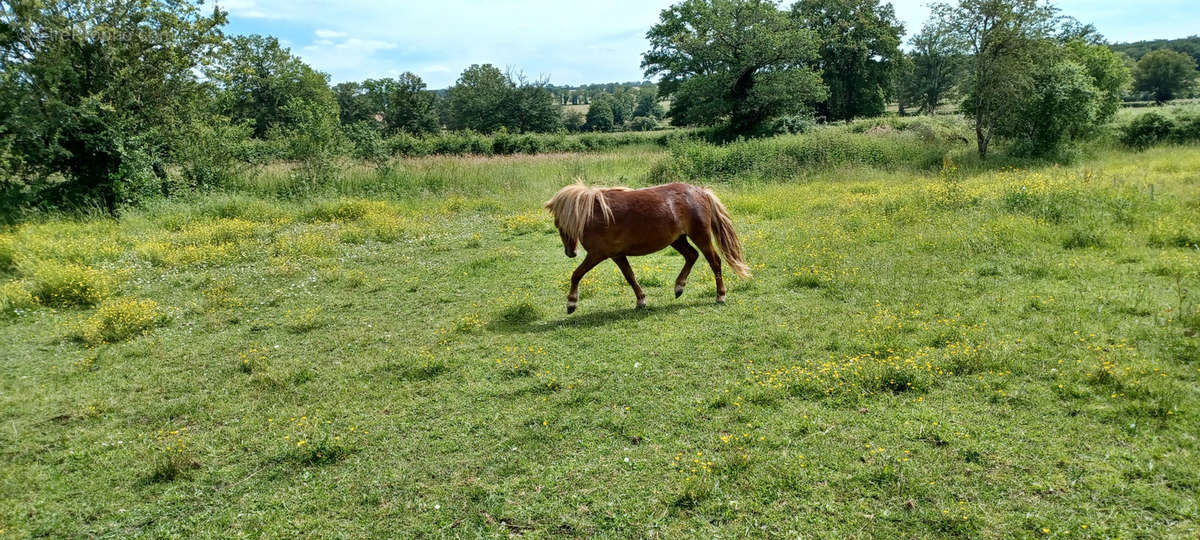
<box><xmin>217</xmin><ymin>0</ymin><xmax>1200</xmax><ymax>89</ymax></box>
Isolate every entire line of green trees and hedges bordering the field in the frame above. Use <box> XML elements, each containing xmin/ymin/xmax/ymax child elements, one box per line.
<box><xmin>0</xmin><ymin>0</ymin><xmax>1195</xmax><ymax>211</ymax></box>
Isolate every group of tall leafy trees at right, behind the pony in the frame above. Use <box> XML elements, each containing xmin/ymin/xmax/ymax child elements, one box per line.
<box><xmin>642</xmin><ymin>0</ymin><xmax>1196</xmax><ymax>157</ymax></box>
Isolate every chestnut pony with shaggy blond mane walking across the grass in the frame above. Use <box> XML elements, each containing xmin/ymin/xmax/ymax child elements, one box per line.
<box><xmin>546</xmin><ymin>182</ymin><xmax>750</xmax><ymax>313</ymax></box>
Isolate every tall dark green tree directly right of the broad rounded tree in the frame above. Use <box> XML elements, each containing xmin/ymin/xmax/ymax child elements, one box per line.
<box><xmin>792</xmin><ymin>0</ymin><xmax>904</xmax><ymax>120</ymax></box>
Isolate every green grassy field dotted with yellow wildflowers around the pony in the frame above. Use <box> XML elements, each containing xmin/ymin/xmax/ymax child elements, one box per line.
<box><xmin>0</xmin><ymin>141</ymin><xmax>1200</xmax><ymax>539</ymax></box>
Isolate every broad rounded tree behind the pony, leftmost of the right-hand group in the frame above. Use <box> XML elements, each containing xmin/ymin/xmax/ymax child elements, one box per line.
<box><xmin>642</xmin><ymin>0</ymin><xmax>826</xmax><ymax>136</ymax></box>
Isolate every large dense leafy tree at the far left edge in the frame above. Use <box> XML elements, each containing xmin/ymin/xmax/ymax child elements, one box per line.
<box><xmin>0</xmin><ymin>0</ymin><xmax>226</xmax><ymax>211</ymax></box>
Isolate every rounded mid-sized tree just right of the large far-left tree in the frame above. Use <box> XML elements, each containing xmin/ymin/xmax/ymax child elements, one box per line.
<box><xmin>209</xmin><ymin>35</ymin><xmax>337</xmax><ymax>138</ymax></box>
